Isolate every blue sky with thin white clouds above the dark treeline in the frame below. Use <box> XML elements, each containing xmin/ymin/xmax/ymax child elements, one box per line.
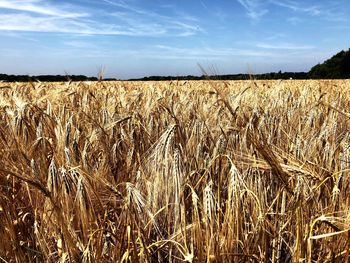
<box><xmin>0</xmin><ymin>0</ymin><xmax>350</xmax><ymax>79</ymax></box>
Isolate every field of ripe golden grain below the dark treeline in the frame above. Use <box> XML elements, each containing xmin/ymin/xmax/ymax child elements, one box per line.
<box><xmin>0</xmin><ymin>80</ymin><xmax>350</xmax><ymax>262</ymax></box>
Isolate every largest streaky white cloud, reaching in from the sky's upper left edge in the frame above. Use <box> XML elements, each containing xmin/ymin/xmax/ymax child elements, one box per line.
<box><xmin>0</xmin><ymin>0</ymin><xmax>203</xmax><ymax>36</ymax></box>
